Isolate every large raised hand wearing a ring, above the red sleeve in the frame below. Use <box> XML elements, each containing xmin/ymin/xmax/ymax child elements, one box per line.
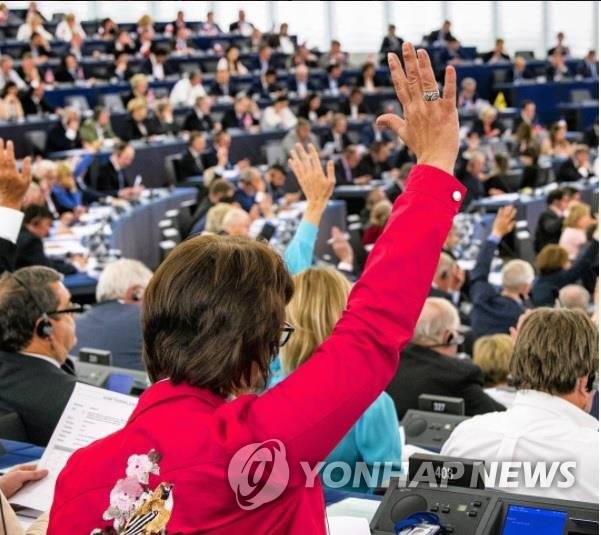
<box><xmin>378</xmin><ymin>41</ymin><xmax>459</xmax><ymax>174</ymax></box>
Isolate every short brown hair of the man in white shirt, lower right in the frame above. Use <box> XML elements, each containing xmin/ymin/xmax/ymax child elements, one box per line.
<box><xmin>509</xmin><ymin>308</ymin><xmax>599</xmax><ymax>395</ymax></box>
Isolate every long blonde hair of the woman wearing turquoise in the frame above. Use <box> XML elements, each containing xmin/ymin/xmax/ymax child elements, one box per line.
<box><xmin>280</xmin><ymin>267</ymin><xmax>351</xmax><ymax>373</ymax></box>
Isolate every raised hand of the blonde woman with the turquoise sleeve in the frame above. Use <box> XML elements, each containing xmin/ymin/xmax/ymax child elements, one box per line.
<box><xmin>288</xmin><ymin>143</ymin><xmax>336</xmax><ymax>225</ymax></box>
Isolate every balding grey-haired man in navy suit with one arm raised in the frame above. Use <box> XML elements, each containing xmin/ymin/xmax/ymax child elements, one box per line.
<box><xmin>470</xmin><ymin>206</ymin><xmax>534</xmax><ymax>338</ymax></box>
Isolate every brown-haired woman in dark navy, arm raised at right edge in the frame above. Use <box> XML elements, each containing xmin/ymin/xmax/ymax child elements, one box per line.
<box><xmin>531</xmin><ymin>239</ymin><xmax>599</xmax><ymax>307</ymax></box>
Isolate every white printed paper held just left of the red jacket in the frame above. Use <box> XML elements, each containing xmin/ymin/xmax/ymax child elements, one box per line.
<box><xmin>10</xmin><ymin>383</ymin><xmax>138</xmax><ymax>512</ymax></box>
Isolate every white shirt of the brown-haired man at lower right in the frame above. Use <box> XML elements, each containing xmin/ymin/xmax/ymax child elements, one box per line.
<box><xmin>441</xmin><ymin>390</ymin><xmax>599</xmax><ymax>503</ymax></box>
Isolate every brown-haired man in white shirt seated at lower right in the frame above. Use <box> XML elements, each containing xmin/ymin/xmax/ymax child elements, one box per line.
<box><xmin>440</xmin><ymin>308</ymin><xmax>599</xmax><ymax>504</ymax></box>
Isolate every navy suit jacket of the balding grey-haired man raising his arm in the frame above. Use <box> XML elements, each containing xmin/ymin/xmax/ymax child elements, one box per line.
<box><xmin>470</xmin><ymin>239</ymin><xmax>525</xmax><ymax>338</ymax></box>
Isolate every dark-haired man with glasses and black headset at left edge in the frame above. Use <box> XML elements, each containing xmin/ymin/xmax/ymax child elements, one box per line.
<box><xmin>0</xmin><ymin>266</ymin><xmax>78</xmax><ymax>446</ymax></box>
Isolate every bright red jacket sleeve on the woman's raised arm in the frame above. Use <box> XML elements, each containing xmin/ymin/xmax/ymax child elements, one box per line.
<box><xmin>232</xmin><ymin>165</ymin><xmax>465</xmax><ymax>476</ymax></box>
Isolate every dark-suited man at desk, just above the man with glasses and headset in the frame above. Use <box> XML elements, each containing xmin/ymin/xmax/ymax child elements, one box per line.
<box><xmin>15</xmin><ymin>204</ymin><xmax>79</xmax><ymax>275</ymax></box>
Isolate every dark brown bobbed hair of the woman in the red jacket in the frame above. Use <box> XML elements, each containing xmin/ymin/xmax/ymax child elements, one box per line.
<box><xmin>142</xmin><ymin>235</ymin><xmax>293</xmax><ymax>396</ymax></box>
